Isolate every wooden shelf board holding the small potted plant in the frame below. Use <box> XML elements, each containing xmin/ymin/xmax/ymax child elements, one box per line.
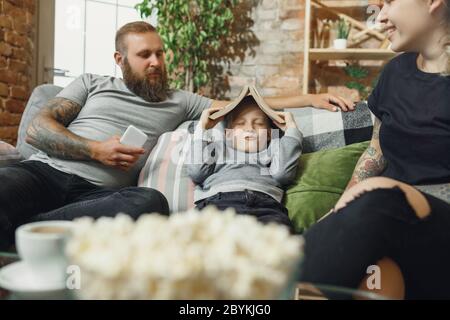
<box><xmin>309</xmin><ymin>48</ymin><xmax>397</xmax><ymax>60</ymax></box>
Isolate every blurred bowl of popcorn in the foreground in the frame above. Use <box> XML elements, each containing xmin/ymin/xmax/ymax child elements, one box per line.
<box><xmin>66</xmin><ymin>207</ymin><xmax>303</xmax><ymax>300</ymax></box>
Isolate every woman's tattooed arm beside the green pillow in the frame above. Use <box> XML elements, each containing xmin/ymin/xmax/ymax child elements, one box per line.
<box><xmin>347</xmin><ymin>118</ymin><xmax>387</xmax><ymax>189</ymax></box>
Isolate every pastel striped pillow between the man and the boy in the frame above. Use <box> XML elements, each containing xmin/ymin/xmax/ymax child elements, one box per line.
<box><xmin>138</xmin><ymin>121</ymin><xmax>195</xmax><ymax>212</ymax></box>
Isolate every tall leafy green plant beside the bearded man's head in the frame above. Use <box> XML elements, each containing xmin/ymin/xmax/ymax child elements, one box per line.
<box><xmin>135</xmin><ymin>0</ymin><xmax>238</xmax><ymax>92</ymax></box>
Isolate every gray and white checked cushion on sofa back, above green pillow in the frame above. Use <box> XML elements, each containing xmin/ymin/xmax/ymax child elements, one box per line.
<box><xmin>290</xmin><ymin>102</ymin><xmax>374</xmax><ymax>153</ymax></box>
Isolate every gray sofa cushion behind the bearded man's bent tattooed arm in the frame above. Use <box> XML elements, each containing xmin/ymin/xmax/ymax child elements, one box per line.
<box><xmin>17</xmin><ymin>84</ymin><xmax>62</xmax><ymax>159</ymax></box>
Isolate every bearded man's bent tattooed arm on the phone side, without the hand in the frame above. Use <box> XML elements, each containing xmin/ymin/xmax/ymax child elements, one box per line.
<box><xmin>26</xmin><ymin>98</ymin><xmax>93</xmax><ymax>160</ymax></box>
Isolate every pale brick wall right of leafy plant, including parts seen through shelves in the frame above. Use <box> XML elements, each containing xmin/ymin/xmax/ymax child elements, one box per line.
<box><xmin>227</xmin><ymin>0</ymin><xmax>382</xmax><ymax>99</ymax></box>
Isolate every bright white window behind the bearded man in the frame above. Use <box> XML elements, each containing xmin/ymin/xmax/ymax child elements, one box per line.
<box><xmin>53</xmin><ymin>0</ymin><xmax>157</xmax><ymax>87</ymax></box>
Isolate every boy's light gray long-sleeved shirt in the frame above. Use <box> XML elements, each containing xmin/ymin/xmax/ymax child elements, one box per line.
<box><xmin>186</xmin><ymin>127</ymin><xmax>303</xmax><ymax>202</ymax></box>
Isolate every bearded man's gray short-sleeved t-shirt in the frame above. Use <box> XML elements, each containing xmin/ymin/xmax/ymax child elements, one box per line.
<box><xmin>30</xmin><ymin>74</ymin><xmax>212</xmax><ymax>188</ymax></box>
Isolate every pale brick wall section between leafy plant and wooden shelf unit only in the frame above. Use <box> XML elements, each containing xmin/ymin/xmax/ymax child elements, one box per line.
<box><xmin>228</xmin><ymin>0</ymin><xmax>304</xmax><ymax>97</ymax></box>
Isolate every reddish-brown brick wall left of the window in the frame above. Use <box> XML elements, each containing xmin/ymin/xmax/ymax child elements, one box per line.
<box><xmin>0</xmin><ymin>0</ymin><xmax>36</xmax><ymax>144</ymax></box>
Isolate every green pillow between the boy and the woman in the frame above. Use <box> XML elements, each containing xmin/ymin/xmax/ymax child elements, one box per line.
<box><xmin>285</xmin><ymin>141</ymin><xmax>369</xmax><ymax>232</ymax></box>
